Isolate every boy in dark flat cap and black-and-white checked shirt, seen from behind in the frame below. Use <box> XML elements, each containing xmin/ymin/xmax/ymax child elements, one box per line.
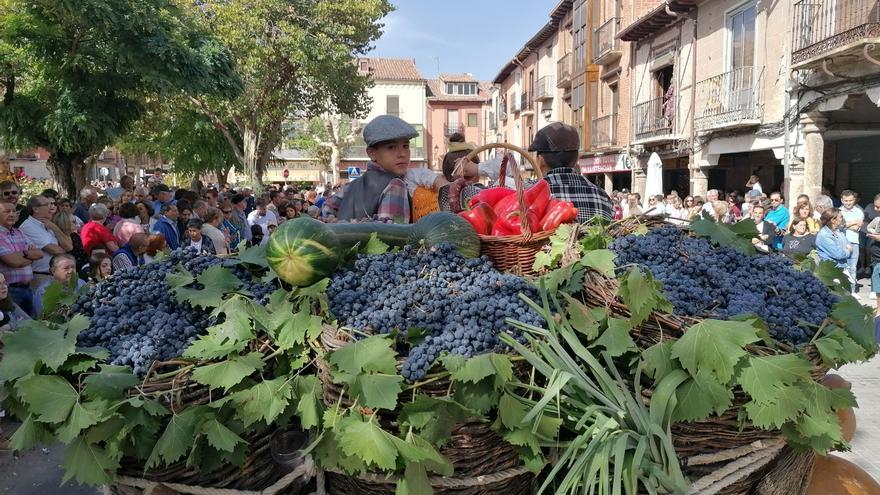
<box><xmin>529</xmin><ymin>122</ymin><xmax>614</xmax><ymax>223</ymax></box>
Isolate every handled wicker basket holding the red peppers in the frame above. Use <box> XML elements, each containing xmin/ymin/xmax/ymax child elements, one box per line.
<box><xmin>462</xmin><ymin>143</ymin><xmax>553</xmax><ymax>275</ymax></box>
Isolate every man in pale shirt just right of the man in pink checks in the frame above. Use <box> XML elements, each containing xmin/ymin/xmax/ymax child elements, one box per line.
<box><xmin>21</xmin><ymin>196</ymin><xmax>73</xmax><ymax>289</ymax></box>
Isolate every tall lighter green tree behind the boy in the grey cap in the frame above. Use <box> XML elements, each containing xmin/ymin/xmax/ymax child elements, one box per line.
<box><xmin>191</xmin><ymin>0</ymin><xmax>392</xmax><ymax>188</ymax></box>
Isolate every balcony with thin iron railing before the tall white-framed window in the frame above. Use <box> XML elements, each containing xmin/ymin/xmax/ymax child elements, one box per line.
<box><xmin>694</xmin><ymin>67</ymin><xmax>764</xmax><ymax>132</ymax></box>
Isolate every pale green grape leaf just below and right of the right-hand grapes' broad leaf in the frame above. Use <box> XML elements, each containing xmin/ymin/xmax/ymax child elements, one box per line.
<box><xmin>737</xmin><ymin>354</ymin><xmax>813</xmax><ymax>406</ymax></box>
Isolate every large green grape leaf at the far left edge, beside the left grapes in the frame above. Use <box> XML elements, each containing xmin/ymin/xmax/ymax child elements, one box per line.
<box><xmin>0</xmin><ymin>315</ymin><xmax>81</xmax><ymax>380</ymax></box>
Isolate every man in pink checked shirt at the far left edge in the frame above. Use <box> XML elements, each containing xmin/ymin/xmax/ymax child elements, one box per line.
<box><xmin>0</xmin><ymin>202</ymin><xmax>43</xmax><ymax>316</ymax></box>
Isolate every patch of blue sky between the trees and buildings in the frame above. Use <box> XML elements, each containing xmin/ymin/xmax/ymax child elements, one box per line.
<box><xmin>369</xmin><ymin>0</ymin><xmax>557</xmax><ymax>81</ymax></box>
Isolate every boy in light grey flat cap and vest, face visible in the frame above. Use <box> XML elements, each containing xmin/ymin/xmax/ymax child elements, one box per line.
<box><xmin>337</xmin><ymin>115</ymin><xmax>419</xmax><ymax>223</ymax></box>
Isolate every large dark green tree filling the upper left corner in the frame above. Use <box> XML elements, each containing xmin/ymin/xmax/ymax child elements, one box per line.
<box><xmin>0</xmin><ymin>0</ymin><xmax>242</xmax><ymax>195</ymax></box>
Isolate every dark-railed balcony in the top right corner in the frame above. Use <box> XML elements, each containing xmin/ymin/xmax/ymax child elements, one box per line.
<box><xmin>791</xmin><ymin>0</ymin><xmax>880</xmax><ymax>69</ymax></box>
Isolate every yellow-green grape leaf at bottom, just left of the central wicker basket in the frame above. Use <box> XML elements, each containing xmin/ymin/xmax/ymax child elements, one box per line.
<box><xmin>336</xmin><ymin>416</ymin><xmax>397</xmax><ymax>471</ymax></box>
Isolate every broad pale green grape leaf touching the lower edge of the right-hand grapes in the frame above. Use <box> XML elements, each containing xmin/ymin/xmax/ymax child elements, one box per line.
<box><xmin>672</xmin><ymin>320</ymin><xmax>760</xmax><ymax>386</ymax></box>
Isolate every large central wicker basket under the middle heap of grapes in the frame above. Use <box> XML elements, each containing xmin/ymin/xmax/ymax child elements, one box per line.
<box><xmin>316</xmin><ymin>326</ymin><xmax>534</xmax><ymax>495</ymax></box>
